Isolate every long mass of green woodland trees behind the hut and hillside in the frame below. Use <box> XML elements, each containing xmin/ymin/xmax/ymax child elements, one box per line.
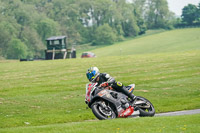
<box><xmin>0</xmin><ymin>0</ymin><xmax>195</xmax><ymax>59</ymax></box>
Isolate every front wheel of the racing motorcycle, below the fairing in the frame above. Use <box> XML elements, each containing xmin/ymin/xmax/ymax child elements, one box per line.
<box><xmin>91</xmin><ymin>101</ymin><xmax>116</xmax><ymax>120</ymax></box>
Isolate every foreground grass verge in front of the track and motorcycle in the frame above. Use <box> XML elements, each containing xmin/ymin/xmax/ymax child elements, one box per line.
<box><xmin>0</xmin><ymin>114</ymin><xmax>200</xmax><ymax>133</ymax></box>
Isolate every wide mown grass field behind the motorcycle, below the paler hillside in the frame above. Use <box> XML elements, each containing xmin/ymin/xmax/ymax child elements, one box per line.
<box><xmin>0</xmin><ymin>50</ymin><xmax>200</xmax><ymax>128</ymax></box>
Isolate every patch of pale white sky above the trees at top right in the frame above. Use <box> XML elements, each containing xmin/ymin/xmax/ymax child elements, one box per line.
<box><xmin>167</xmin><ymin>0</ymin><xmax>200</xmax><ymax>16</ymax></box>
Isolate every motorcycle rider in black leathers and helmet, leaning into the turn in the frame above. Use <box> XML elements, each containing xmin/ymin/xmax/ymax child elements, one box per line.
<box><xmin>86</xmin><ymin>67</ymin><xmax>135</xmax><ymax>100</ymax></box>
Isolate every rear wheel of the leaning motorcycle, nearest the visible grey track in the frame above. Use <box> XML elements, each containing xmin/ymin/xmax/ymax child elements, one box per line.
<box><xmin>135</xmin><ymin>96</ymin><xmax>155</xmax><ymax>116</ymax></box>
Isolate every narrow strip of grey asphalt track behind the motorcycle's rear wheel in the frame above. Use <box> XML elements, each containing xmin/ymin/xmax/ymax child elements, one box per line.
<box><xmin>155</xmin><ymin>109</ymin><xmax>200</xmax><ymax>116</ymax></box>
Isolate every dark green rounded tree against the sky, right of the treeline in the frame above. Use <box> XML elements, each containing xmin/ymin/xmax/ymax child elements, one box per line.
<box><xmin>181</xmin><ymin>4</ymin><xmax>198</xmax><ymax>25</ymax></box>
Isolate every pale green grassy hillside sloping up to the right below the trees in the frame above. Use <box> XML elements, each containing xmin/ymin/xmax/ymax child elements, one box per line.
<box><xmin>82</xmin><ymin>28</ymin><xmax>200</xmax><ymax>57</ymax></box>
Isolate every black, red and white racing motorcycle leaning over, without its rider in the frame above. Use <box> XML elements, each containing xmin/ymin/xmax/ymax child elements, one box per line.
<box><xmin>85</xmin><ymin>83</ymin><xmax>155</xmax><ymax>120</ymax></box>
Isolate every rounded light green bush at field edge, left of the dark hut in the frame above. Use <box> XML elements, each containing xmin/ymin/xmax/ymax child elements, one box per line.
<box><xmin>7</xmin><ymin>39</ymin><xmax>27</xmax><ymax>59</ymax></box>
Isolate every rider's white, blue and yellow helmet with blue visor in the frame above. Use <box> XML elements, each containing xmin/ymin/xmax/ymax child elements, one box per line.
<box><xmin>86</xmin><ymin>67</ymin><xmax>100</xmax><ymax>82</ymax></box>
